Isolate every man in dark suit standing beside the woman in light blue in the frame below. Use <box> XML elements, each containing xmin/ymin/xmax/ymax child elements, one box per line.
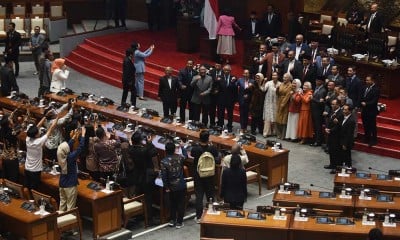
<box><xmin>121</xmin><ymin>48</ymin><xmax>136</xmax><ymax>106</ymax></box>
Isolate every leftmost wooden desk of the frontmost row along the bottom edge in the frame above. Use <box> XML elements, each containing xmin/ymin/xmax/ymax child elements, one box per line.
<box><xmin>200</xmin><ymin>212</ymin><xmax>291</xmax><ymax>240</ymax></box>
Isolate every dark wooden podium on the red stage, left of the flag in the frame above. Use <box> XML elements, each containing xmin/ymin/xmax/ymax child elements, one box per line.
<box><xmin>176</xmin><ymin>17</ymin><xmax>200</xmax><ymax>53</ymax></box>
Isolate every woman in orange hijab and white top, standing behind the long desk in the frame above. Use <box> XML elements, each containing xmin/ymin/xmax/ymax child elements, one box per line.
<box><xmin>50</xmin><ymin>58</ymin><xmax>69</xmax><ymax>92</ymax></box>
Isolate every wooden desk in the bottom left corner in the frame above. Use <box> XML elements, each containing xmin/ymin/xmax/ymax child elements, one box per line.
<box><xmin>0</xmin><ymin>196</ymin><xmax>59</xmax><ymax>240</ymax></box>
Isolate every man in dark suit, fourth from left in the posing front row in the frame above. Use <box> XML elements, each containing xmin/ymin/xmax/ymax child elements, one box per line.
<box><xmin>217</xmin><ymin>65</ymin><xmax>238</xmax><ymax>132</ymax></box>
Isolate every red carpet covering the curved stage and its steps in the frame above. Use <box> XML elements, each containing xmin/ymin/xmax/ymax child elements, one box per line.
<box><xmin>66</xmin><ymin>29</ymin><xmax>400</xmax><ymax>158</ymax></box>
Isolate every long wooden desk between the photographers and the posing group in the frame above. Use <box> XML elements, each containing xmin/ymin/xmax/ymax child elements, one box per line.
<box><xmin>41</xmin><ymin>94</ymin><xmax>289</xmax><ymax>189</ymax></box>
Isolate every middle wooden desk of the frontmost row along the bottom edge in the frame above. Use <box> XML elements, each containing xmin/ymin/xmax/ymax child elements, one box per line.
<box><xmin>289</xmin><ymin>218</ymin><xmax>374</xmax><ymax>240</ymax></box>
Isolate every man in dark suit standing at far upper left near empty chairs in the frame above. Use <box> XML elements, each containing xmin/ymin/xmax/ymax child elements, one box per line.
<box><xmin>4</xmin><ymin>22</ymin><xmax>21</xmax><ymax>77</ymax></box>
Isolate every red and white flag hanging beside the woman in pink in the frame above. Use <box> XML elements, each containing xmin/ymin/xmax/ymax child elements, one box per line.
<box><xmin>204</xmin><ymin>0</ymin><xmax>219</xmax><ymax>39</ymax></box>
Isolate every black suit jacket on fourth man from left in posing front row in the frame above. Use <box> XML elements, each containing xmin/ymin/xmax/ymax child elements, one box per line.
<box><xmin>217</xmin><ymin>75</ymin><xmax>238</xmax><ymax>106</ymax></box>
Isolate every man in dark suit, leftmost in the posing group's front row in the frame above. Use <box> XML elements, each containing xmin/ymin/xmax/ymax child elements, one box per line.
<box><xmin>158</xmin><ymin>67</ymin><xmax>179</xmax><ymax>117</ymax></box>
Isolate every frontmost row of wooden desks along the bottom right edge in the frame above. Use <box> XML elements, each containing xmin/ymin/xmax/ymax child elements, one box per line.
<box><xmin>200</xmin><ymin>212</ymin><xmax>400</xmax><ymax>240</ymax></box>
